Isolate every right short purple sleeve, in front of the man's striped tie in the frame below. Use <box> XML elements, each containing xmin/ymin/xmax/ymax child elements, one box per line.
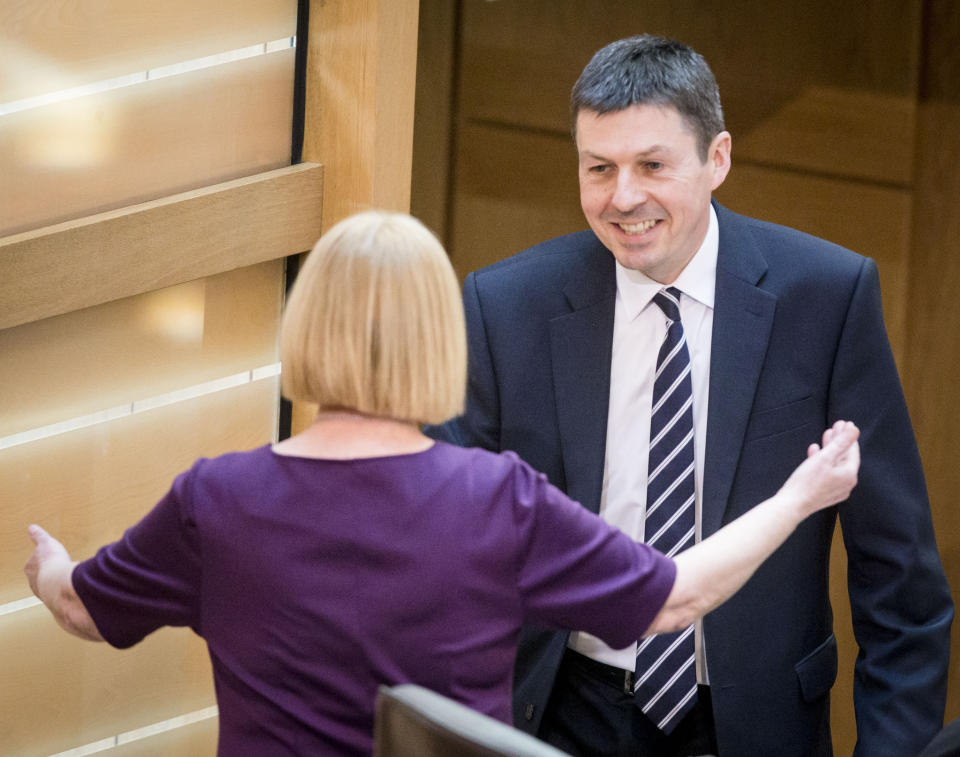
<box><xmin>513</xmin><ymin>463</ymin><xmax>677</xmax><ymax>649</ymax></box>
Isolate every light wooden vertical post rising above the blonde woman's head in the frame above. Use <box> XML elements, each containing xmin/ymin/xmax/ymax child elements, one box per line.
<box><xmin>303</xmin><ymin>0</ymin><xmax>418</xmax><ymax>230</ymax></box>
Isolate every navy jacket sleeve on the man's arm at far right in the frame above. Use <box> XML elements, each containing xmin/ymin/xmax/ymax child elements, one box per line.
<box><xmin>829</xmin><ymin>260</ymin><xmax>953</xmax><ymax>757</ymax></box>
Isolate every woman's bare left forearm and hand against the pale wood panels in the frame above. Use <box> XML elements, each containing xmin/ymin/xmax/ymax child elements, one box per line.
<box><xmin>23</xmin><ymin>525</ymin><xmax>103</xmax><ymax>641</ymax></box>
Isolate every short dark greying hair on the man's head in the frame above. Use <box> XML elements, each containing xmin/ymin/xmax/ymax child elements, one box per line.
<box><xmin>570</xmin><ymin>34</ymin><xmax>724</xmax><ymax>161</ymax></box>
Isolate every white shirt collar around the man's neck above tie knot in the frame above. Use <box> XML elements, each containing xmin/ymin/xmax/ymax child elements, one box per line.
<box><xmin>616</xmin><ymin>204</ymin><xmax>720</xmax><ymax>320</ymax></box>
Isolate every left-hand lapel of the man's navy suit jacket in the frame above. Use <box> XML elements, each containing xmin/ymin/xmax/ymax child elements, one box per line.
<box><xmin>550</xmin><ymin>239</ymin><xmax>617</xmax><ymax>512</ymax></box>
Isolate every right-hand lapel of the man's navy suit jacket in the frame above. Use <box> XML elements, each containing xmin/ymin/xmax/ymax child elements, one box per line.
<box><xmin>702</xmin><ymin>203</ymin><xmax>777</xmax><ymax>536</ymax></box>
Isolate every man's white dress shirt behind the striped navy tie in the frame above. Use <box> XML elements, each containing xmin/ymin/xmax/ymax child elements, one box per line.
<box><xmin>569</xmin><ymin>206</ymin><xmax>720</xmax><ymax>683</ymax></box>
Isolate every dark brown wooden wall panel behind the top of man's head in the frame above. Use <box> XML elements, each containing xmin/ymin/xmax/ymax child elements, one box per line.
<box><xmin>460</xmin><ymin>0</ymin><xmax>920</xmax><ymax>183</ymax></box>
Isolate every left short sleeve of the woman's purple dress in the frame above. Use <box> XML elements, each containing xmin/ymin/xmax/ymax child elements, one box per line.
<box><xmin>72</xmin><ymin>467</ymin><xmax>200</xmax><ymax>649</ymax></box>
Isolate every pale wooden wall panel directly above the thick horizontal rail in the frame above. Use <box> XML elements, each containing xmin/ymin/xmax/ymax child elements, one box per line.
<box><xmin>0</xmin><ymin>50</ymin><xmax>294</xmax><ymax>235</ymax></box>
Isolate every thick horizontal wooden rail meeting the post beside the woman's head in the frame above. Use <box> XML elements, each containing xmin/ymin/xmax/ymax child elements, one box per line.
<box><xmin>0</xmin><ymin>163</ymin><xmax>323</xmax><ymax>328</ymax></box>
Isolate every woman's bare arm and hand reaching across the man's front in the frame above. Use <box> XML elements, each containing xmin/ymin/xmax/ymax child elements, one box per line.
<box><xmin>645</xmin><ymin>421</ymin><xmax>860</xmax><ymax>636</ymax></box>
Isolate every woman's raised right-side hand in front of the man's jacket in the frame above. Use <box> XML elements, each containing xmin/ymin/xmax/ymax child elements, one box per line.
<box><xmin>780</xmin><ymin>421</ymin><xmax>860</xmax><ymax>517</ymax></box>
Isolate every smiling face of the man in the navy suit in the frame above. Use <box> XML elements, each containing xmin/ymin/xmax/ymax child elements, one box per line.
<box><xmin>577</xmin><ymin>105</ymin><xmax>730</xmax><ymax>284</ymax></box>
